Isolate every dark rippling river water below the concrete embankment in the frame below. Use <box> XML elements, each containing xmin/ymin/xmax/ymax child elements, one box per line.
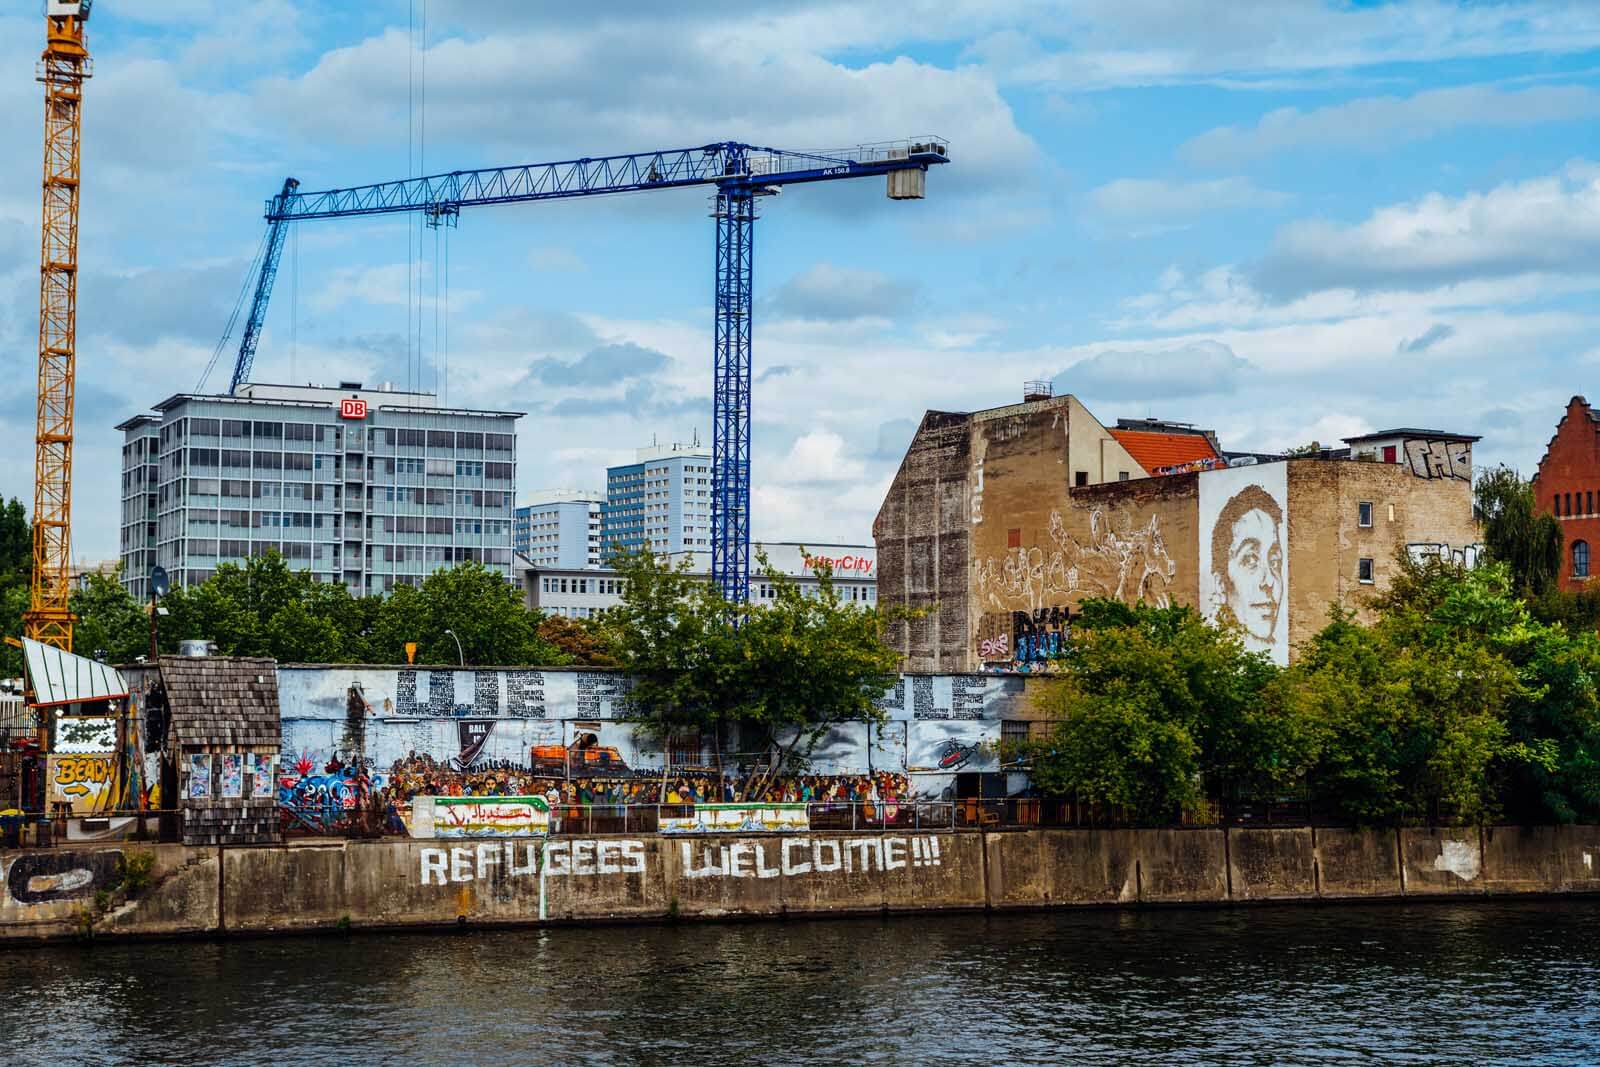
<box><xmin>0</xmin><ymin>901</ymin><xmax>1600</xmax><ymax>1067</ymax></box>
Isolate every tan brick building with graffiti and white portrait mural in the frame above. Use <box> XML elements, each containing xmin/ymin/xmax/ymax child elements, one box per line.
<box><xmin>874</xmin><ymin>397</ymin><xmax>1478</xmax><ymax>672</ymax></box>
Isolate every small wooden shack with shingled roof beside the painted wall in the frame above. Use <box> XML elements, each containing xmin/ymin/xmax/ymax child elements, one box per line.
<box><xmin>162</xmin><ymin>656</ymin><xmax>282</xmax><ymax>845</ymax></box>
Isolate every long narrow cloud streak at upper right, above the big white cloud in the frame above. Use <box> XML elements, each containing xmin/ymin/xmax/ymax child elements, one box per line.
<box><xmin>1178</xmin><ymin>85</ymin><xmax>1600</xmax><ymax>166</ymax></box>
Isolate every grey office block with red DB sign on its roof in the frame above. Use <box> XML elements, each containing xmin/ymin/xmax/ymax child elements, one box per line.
<box><xmin>117</xmin><ymin>384</ymin><xmax>522</xmax><ymax>600</ymax></box>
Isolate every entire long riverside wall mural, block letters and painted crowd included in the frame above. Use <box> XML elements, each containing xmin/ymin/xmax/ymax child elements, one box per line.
<box><xmin>278</xmin><ymin>665</ymin><xmax>1022</xmax><ymax>833</ymax></box>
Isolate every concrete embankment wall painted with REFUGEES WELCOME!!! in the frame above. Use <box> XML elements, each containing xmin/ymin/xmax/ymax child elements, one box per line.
<box><xmin>0</xmin><ymin>827</ymin><xmax>1600</xmax><ymax>941</ymax></box>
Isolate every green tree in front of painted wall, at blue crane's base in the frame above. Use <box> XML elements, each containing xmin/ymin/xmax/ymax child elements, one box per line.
<box><xmin>602</xmin><ymin>549</ymin><xmax>899</xmax><ymax>795</ymax></box>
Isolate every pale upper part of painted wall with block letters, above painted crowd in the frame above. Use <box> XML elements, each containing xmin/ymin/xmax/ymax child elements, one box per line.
<box><xmin>278</xmin><ymin>665</ymin><xmax>1026</xmax><ymax>803</ymax></box>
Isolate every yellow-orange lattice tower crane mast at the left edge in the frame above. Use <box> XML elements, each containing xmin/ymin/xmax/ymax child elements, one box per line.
<box><xmin>22</xmin><ymin>0</ymin><xmax>91</xmax><ymax>651</ymax></box>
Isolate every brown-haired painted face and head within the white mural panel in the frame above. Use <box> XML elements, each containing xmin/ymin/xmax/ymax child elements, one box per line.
<box><xmin>1211</xmin><ymin>485</ymin><xmax>1286</xmax><ymax>651</ymax></box>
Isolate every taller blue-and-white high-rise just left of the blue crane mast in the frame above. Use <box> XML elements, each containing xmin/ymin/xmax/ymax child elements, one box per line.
<box><xmin>600</xmin><ymin>443</ymin><xmax>710</xmax><ymax>558</ymax></box>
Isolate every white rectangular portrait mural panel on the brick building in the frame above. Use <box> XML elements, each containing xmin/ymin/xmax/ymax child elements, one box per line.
<box><xmin>1200</xmin><ymin>462</ymin><xmax>1290</xmax><ymax>664</ymax></box>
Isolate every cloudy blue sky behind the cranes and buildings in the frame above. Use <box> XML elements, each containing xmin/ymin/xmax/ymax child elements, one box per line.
<box><xmin>0</xmin><ymin>0</ymin><xmax>1600</xmax><ymax>560</ymax></box>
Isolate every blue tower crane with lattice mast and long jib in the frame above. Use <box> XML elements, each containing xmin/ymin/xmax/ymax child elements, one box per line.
<box><xmin>206</xmin><ymin>138</ymin><xmax>949</xmax><ymax>603</ymax></box>
